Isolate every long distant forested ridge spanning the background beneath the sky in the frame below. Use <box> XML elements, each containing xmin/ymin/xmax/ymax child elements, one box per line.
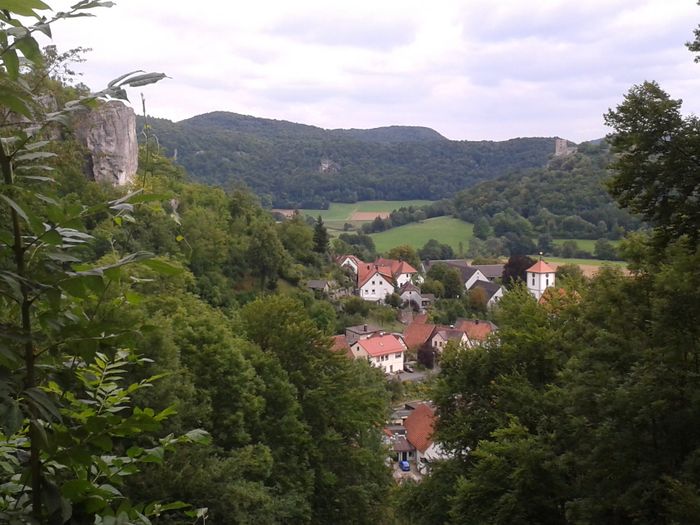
<box><xmin>139</xmin><ymin>112</ymin><xmax>554</xmax><ymax>207</ymax></box>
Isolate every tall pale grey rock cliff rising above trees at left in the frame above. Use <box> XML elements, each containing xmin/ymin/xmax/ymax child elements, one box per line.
<box><xmin>74</xmin><ymin>100</ymin><xmax>138</xmax><ymax>186</ymax></box>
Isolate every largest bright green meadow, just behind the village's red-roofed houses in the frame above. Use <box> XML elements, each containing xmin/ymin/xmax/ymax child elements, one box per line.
<box><xmin>370</xmin><ymin>217</ymin><xmax>473</xmax><ymax>253</ymax></box>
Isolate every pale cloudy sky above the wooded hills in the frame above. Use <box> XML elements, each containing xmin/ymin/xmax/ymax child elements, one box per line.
<box><xmin>46</xmin><ymin>0</ymin><xmax>700</xmax><ymax>142</ymax></box>
